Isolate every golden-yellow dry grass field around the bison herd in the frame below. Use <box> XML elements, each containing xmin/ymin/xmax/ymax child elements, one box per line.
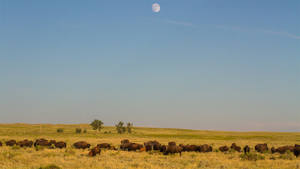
<box><xmin>0</xmin><ymin>124</ymin><xmax>300</xmax><ymax>169</ymax></box>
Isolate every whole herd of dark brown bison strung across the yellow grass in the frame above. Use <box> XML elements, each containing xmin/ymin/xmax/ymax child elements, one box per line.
<box><xmin>0</xmin><ymin>138</ymin><xmax>300</xmax><ymax>157</ymax></box>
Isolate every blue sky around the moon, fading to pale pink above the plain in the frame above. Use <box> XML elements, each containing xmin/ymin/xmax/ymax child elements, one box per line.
<box><xmin>0</xmin><ymin>0</ymin><xmax>300</xmax><ymax>132</ymax></box>
